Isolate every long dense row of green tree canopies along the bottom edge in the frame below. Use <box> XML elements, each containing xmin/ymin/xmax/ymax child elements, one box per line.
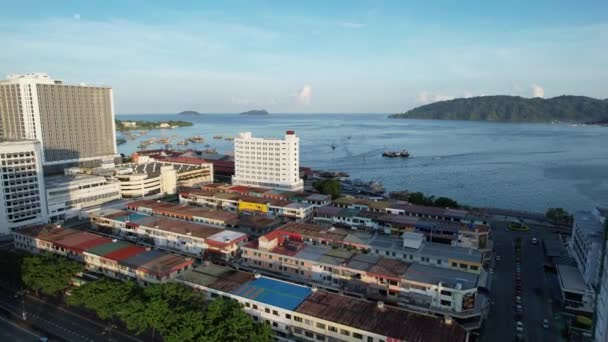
<box><xmin>68</xmin><ymin>279</ymin><xmax>273</xmax><ymax>342</ymax></box>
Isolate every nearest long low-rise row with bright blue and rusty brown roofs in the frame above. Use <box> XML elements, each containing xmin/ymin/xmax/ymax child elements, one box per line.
<box><xmin>177</xmin><ymin>264</ymin><xmax>469</xmax><ymax>342</ymax></box>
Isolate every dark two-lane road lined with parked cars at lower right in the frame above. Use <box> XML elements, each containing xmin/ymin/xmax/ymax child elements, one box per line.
<box><xmin>481</xmin><ymin>222</ymin><xmax>559</xmax><ymax>342</ymax></box>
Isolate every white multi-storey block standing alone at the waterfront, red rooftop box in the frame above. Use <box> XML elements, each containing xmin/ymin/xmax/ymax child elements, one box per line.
<box><xmin>232</xmin><ymin>131</ymin><xmax>304</xmax><ymax>191</ymax></box>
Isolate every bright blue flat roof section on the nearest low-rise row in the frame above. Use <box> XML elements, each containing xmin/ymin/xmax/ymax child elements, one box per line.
<box><xmin>231</xmin><ymin>277</ymin><xmax>312</xmax><ymax>310</ymax></box>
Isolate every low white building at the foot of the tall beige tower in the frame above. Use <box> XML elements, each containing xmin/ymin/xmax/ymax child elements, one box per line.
<box><xmin>45</xmin><ymin>175</ymin><xmax>121</xmax><ymax>222</ymax></box>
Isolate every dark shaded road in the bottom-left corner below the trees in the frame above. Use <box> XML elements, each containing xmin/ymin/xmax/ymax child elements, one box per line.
<box><xmin>0</xmin><ymin>291</ymin><xmax>141</xmax><ymax>342</ymax></box>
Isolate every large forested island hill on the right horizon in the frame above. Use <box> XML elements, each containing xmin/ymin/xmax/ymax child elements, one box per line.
<box><xmin>389</xmin><ymin>95</ymin><xmax>608</xmax><ymax>124</ymax></box>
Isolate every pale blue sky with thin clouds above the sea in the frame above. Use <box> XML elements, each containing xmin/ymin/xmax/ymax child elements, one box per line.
<box><xmin>0</xmin><ymin>0</ymin><xmax>608</xmax><ymax>114</ymax></box>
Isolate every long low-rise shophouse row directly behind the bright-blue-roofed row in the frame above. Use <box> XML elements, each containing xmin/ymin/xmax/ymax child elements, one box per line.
<box><xmin>241</xmin><ymin>229</ymin><xmax>487</xmax><ymax>329</ymax></box>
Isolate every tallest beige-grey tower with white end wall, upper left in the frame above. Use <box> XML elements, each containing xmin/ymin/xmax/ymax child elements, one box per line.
<box><xmin>0</xmin><ymin>74</ymin><xmax>118</xmax><ymax>173</ymax></box>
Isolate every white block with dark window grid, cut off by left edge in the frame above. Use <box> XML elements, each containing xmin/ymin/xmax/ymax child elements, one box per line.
<box><xmin>0</xmin><ymin>140</ymin><xmax>47</xmax><ymax>238</ymax></box>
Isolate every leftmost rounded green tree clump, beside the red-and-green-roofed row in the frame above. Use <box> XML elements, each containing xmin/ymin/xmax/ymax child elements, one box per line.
<box><xmin>21</xmin><ymin>253</ymin><xmax>84</xmax><ymax>296</ymax></box>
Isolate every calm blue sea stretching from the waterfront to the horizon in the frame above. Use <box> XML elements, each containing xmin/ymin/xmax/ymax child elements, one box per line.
<box><xmin>117</xmin><ymin>114</ymin><xmax>608</xmax><ymax>211</ymax></box>
